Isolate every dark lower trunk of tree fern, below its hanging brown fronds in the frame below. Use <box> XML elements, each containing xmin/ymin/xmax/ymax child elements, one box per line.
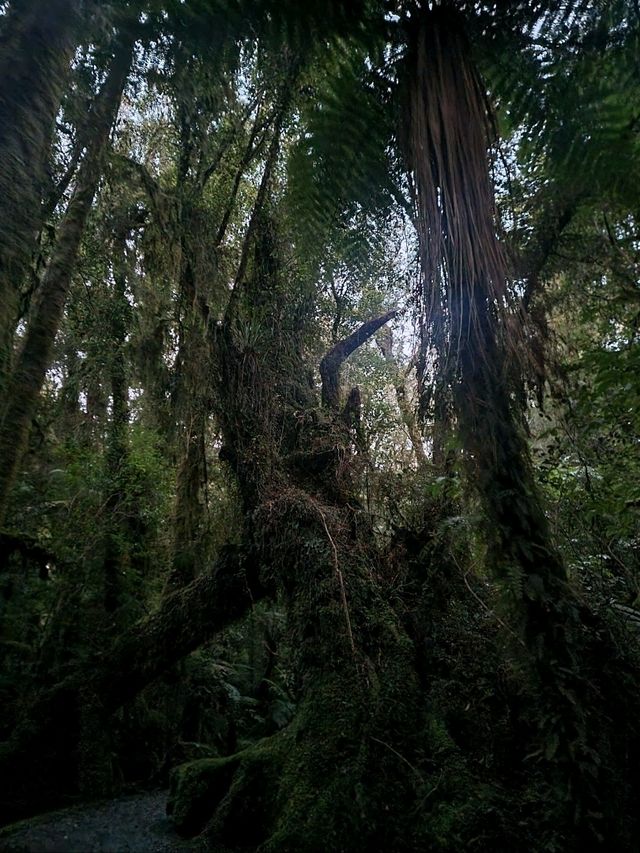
<box><xmin>455</xmin><ymin>298</ymin><xmax>640</xmax><ymax>849</ymax></box>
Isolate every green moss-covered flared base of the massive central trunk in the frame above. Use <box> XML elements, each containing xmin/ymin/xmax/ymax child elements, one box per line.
<box><xmin>180</xmin><ymin>673</ymin><xmax>428</xmax><ymax>853</ymax></box>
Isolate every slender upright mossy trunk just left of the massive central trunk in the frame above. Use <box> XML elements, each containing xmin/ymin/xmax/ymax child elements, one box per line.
<box><xmin>162</xmin><ymin>75</ymin><xmax>254</xmax><ymax>590</ymax></box>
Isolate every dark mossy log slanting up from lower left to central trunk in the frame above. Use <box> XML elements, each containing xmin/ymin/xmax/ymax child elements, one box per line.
<box><xmin>0</xmin><ymin>549</ymin><xmax>269</xmax><ymax>822</ymax></box>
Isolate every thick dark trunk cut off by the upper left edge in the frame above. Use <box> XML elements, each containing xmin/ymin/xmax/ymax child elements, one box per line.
<box><xmin>0</xmin><ymin>0</ymin><xmax>81</xmax><ymax>392</ymax></box>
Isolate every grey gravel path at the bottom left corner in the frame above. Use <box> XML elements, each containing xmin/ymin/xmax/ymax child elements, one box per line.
<box><xmin>0</xmin><ymin>791</ymin><xmax>193</xmax><ymax>853</ymax></box>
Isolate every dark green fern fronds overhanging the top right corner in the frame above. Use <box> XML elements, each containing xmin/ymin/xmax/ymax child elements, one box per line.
<box><xmin>481</xmin><ymin>0</ymin><xmax>640</xmax><ymax>203</ymax></box>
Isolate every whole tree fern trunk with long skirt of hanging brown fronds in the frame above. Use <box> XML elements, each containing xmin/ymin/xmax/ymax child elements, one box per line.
<box><xmin>403</xmin><ymin>2</ymin><xmax>636</xmax><ymax>840</ymax></box>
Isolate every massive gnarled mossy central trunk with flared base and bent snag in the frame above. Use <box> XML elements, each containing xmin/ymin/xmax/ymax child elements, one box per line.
<box><xmin>166</xmin><ymin>218</ymin><xmax>436</xmax><ymax>851</ymax></box>
